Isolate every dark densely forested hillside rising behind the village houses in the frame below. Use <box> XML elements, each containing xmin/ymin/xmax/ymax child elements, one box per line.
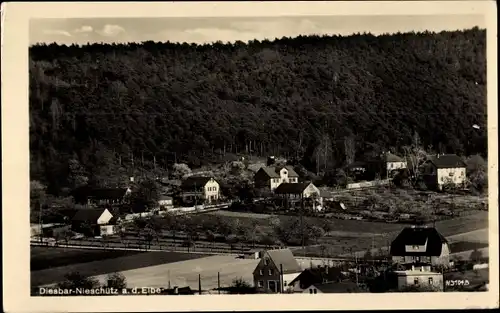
<box><xmin>30</xmin><ymin>29</ymin><xmax>487</xmax><ymax>192</ymax></box>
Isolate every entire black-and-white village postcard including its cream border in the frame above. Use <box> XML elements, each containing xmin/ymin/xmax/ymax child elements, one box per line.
<box><xmin>2</xmin><ymin>1</ymin><xmax>498</xmax><ymax>310</ymax></box>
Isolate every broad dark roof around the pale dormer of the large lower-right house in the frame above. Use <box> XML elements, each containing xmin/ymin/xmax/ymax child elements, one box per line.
<box><xmin>391</xmin><ymin>227</ymin><xmax>448</xmax><ymax>256</ymax></box>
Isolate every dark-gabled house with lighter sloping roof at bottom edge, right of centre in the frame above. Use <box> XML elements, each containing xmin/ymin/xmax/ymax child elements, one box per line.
<box><xmin>253</xmin><ymin>249</ymin><xmax>302</xmax><ymax>293</ymax></box>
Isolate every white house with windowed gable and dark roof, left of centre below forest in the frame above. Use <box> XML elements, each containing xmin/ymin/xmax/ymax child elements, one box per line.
<box><xmin>181</xmin><ymin>176</ymin><xmax>220</xmax><ymax>205</ymax></box>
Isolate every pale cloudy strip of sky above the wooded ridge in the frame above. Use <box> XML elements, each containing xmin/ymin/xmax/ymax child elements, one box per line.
<box><xmin>29</xmin><ymin>15</ymin><xmax>486</xmax><ymax>44</ymax></box>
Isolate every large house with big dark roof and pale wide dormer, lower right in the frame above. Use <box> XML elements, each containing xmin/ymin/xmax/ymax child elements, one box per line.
<box><xmin>390</xmin><ymin>226</ymin><xmax>450</xmax><ymax>270</ymax></box>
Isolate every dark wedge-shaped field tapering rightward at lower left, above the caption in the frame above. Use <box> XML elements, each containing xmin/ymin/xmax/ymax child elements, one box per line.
<box><xmin>31</xmin><ymin>247</ymin><xmax>206</xmax><ymax>286</ymax></box>
